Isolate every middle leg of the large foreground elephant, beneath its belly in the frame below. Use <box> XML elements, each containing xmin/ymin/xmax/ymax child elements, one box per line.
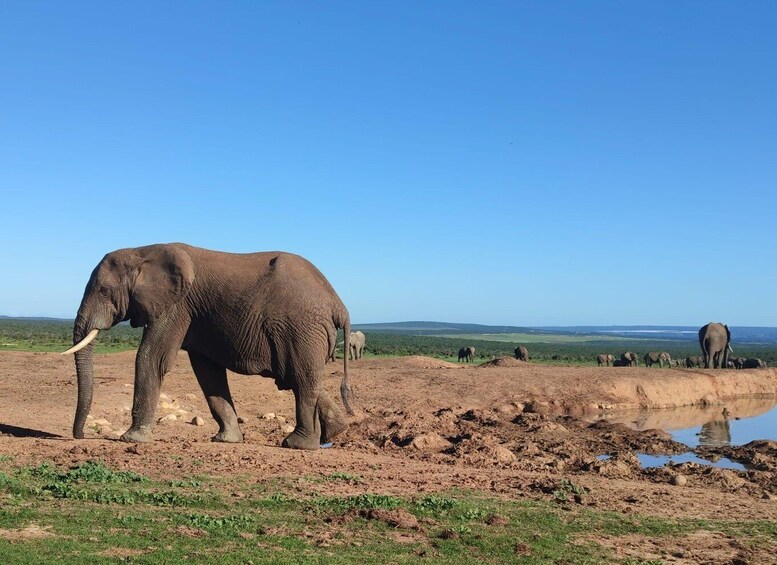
<box><xmin>189</xmin><ymin>351</ymin><xmax>243</xmax><ymax>443</ymax></box>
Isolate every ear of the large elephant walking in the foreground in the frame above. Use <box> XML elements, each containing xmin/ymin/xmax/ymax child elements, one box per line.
<box><xmin>130</xmin><ymin>245</ymin><xmax>194</xmax><ymax>327</ymax></box>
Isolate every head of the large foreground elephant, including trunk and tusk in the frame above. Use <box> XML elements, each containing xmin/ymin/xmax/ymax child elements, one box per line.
<box><xmin>63</xmin><ymin>245</ymin><xmax>194</xmax><ymax>438</ymax></box>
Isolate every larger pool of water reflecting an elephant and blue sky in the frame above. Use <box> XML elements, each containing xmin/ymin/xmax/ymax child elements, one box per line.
<box><xmin>588</xmin><ymin>398</ymin><xmax>777</xmax><ymax>448</ymax></box>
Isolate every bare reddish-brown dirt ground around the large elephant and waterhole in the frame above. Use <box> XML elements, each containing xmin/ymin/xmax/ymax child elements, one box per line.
<box><xmin>0</xmin><ymin>352</ymin><xmax>777</xmax><ymax>562</ymax></box>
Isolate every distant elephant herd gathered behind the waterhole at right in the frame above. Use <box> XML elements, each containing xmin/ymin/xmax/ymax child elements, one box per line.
<box><xmin>596</xmin><ymin>322</ymin><xmax>766</xmax><ymax>369</ymax></box>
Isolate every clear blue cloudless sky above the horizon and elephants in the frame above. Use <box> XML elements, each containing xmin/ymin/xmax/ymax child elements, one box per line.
<box><xmin>0</xmin><ymin>0</ymin><xmax>777</xmax><ymax>326</ymax></box>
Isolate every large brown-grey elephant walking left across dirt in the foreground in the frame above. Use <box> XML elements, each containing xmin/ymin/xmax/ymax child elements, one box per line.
<box><xmin>65</xmin><ymin>243</ymin><xmax>353</xmax><ymax>449</ymax></box>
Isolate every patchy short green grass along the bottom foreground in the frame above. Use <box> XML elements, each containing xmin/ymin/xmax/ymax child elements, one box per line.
<box><xmin>0</xmin><ymin>462</ymin><xmax>777</xmax><ymax>564</ymax></box>
